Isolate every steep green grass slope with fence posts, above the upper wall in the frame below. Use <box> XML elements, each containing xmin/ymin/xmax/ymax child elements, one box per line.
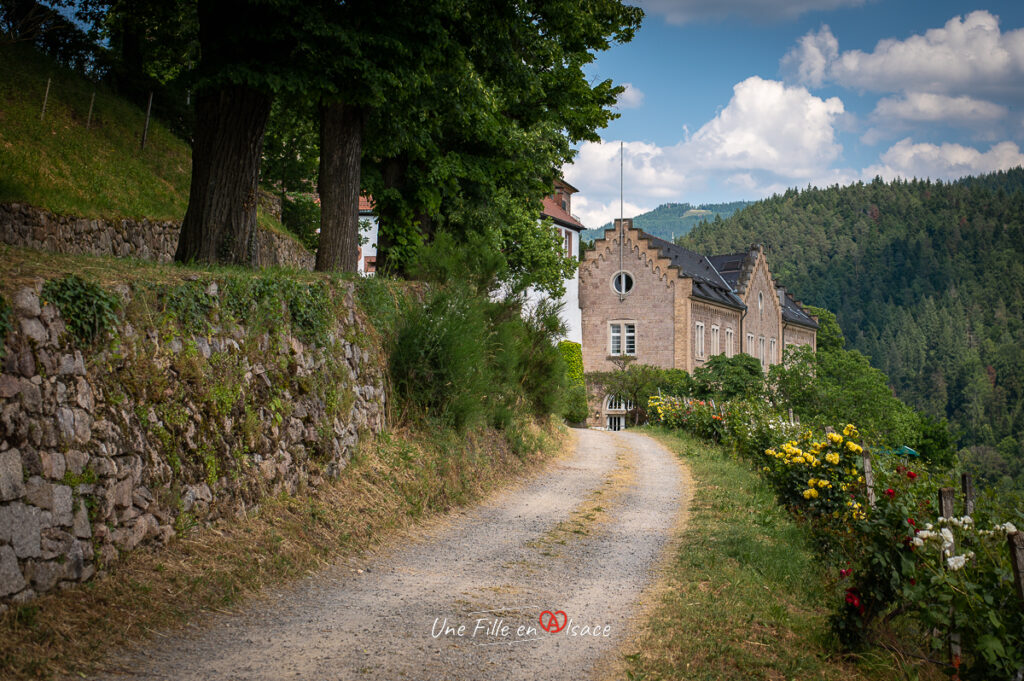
<box><xmin>0</xmin><ymin>44</ymin><xmax>191</xmax><ymax>220</ymax></box>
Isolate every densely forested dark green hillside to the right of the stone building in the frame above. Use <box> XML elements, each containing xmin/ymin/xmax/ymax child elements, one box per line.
<box><xmin>679</xmin><ymin>168</ymin><xmax>1024</xmax><ymax>486</ymax></box>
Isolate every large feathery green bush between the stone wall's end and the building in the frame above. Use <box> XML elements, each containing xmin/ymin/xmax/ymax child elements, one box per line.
<box><xmin>385</xmin><ymin>233</ymin><xmax>565</xmax><ymax>429</ymax></box>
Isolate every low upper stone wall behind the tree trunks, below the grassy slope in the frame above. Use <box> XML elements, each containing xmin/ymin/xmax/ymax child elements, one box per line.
<box><xmin>0</xmin><ymin>204</ymin><xmax>315</xmax><ymax>269</ymax></box>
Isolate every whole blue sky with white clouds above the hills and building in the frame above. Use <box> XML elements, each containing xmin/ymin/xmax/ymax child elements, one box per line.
<box><xmin>563</xmin><ymin>0</ymin><xmax>1024</xmax><ymax>227</ymax></box>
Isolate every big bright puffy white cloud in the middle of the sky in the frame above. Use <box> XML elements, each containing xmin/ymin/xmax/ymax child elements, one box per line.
<box><xmin>684</xmin><ymin>76</ymin><xmax>844</xmax><ymax>178</ymax></box>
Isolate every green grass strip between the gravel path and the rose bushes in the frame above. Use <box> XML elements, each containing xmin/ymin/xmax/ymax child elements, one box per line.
<box><xmin>626</xmin><ymin>430</ymin><xmax>933</xmax><ymax>681</ymax></box>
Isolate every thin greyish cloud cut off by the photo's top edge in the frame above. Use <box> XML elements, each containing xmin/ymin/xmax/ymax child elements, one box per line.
<box><xmin>637</xmin><ymin>0</ymin><xmax>865</xmax><ymax>25</ymax></box>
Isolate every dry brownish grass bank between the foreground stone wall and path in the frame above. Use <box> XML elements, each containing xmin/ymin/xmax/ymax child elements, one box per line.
<box><xmin>0</xmin><ymin>427</ymin><xmax>572</xmax><ymax>680</ymax></box>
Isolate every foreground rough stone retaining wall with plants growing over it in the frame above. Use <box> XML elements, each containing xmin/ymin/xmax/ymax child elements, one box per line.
<box><xmin>0</xmin><ymin>281</ymin><xmax>385</xmax><ymax>611</ymax></box>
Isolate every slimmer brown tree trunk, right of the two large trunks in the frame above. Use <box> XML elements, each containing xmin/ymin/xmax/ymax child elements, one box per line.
<box><xmin>316</xmin><ymin>102</ymin><xmax>362</xmax><ymax>272</ymax></box>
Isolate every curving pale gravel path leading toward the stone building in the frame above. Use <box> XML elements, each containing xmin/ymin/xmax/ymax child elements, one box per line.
<box><xmin>97</xmin><ymin>430</ymin><xmax>684</xmax><ymax>681</ymax></box>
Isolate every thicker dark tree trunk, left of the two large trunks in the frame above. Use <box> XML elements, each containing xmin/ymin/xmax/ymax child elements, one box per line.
<box><xmin>174</xmin><ymin>85</ymin><xmax>270</xmax><ymax>265</ymax></box>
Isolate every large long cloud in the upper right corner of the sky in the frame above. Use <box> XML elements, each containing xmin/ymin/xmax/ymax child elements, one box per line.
<box><xmin>782</xmin><ymin>10</ymin><xmax>1024</xmax><ymax>97</ymax></box>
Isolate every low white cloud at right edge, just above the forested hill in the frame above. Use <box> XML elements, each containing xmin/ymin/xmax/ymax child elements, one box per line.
<box><xmin>863</xmin><ymin>137</ymin><xmax>1024</xmax><ymax>180</ymax></box>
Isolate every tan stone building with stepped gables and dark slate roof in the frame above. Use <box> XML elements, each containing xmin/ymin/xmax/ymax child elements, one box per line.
<box><xmin>580</xmin><ymin>220</ymin><xmax>818</xmax><ymax>428</ymax></box>
